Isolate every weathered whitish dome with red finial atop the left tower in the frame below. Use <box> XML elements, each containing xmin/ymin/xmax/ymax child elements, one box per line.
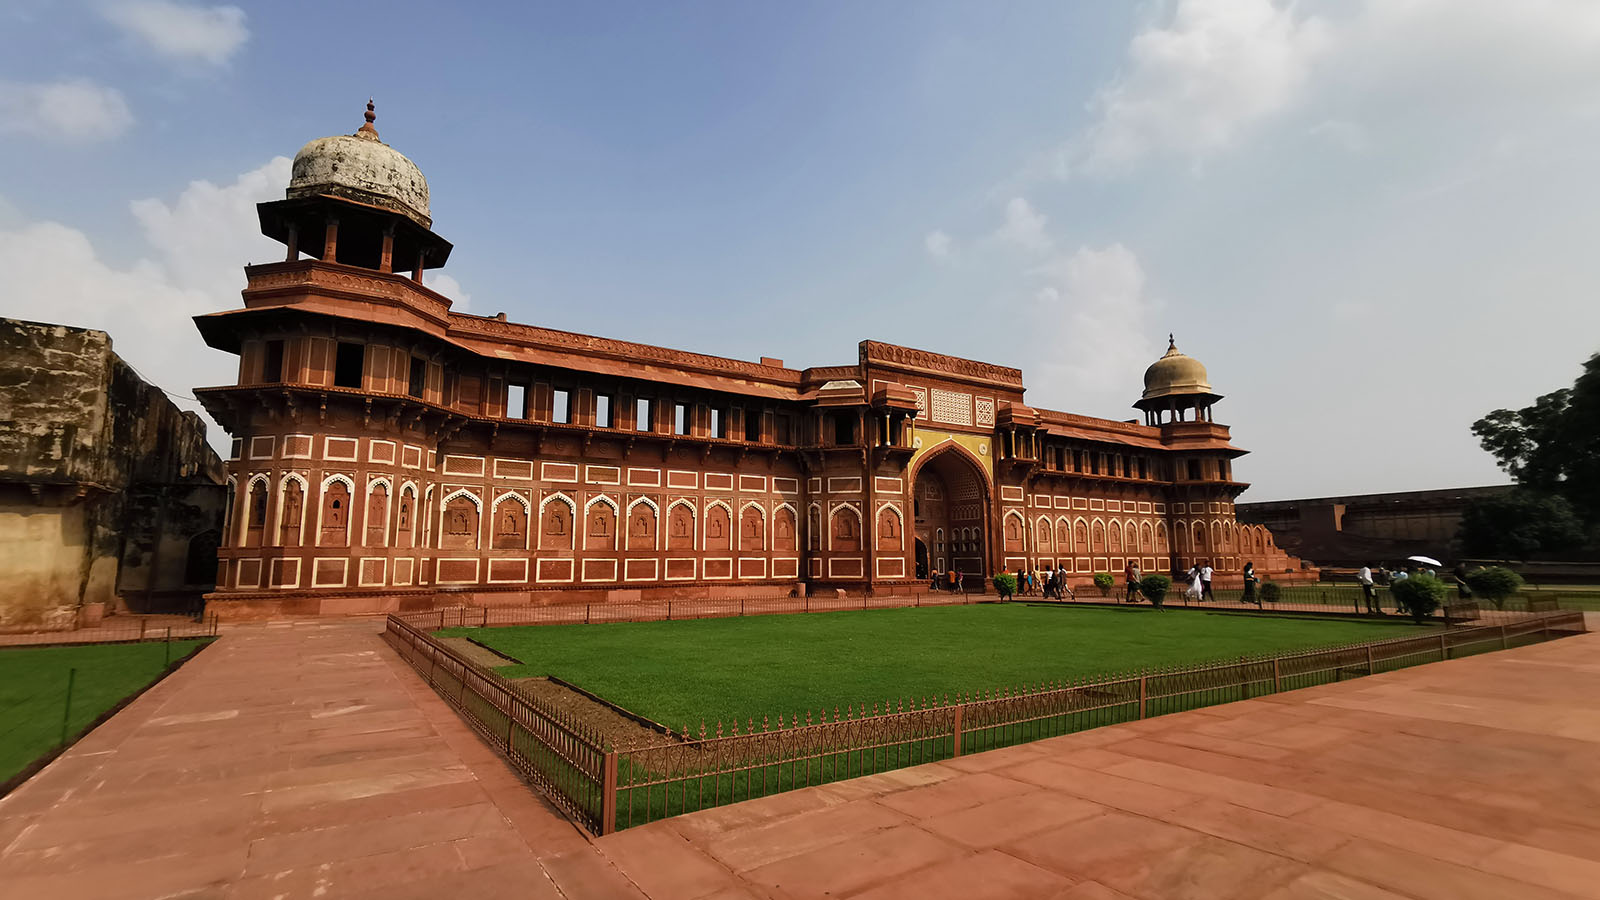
<box><xmin>285</xmin><ymin>102</ymin><xmax>434</xmax><ymax>227</ymax></box>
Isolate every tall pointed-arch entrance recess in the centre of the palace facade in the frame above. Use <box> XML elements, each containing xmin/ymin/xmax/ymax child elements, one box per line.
<box><xmin>912</xmin><ymin>448</ymin><xmax>989</xmax><ymax>589</ymax></box>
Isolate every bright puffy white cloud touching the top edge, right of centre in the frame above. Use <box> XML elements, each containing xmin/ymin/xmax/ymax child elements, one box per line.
<box><xmin>1059</xmin><ymin>0</ymin><xmax>1330</xmax><ymax>173</ymax></box>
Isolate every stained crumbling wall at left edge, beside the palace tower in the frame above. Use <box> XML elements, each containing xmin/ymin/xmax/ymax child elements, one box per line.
<box><xmin>0</xmin><ymin>319</ymin><xmax>226</xmax><ymax>629</ymax></box>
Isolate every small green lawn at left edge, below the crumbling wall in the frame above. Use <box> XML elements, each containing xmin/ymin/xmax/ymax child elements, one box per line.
<box><xmin>0</xmin><ymin>641</ymin><xmax>205</xmax><ymax>781</ymax></box>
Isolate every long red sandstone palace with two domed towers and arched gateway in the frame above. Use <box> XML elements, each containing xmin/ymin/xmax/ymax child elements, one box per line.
<box><xmin>195</xmin><ymin>102</ymin><xmax>1299</xmax><ymax>618</ymax></box>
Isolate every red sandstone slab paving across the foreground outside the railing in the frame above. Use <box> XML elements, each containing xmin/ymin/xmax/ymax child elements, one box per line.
<box><xmin>0</xmin><ymin>623</ymin><xmax>1600</xmax><ymax>900</ymax></box>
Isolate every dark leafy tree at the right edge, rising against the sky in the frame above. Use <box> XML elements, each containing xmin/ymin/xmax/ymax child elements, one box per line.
<box><xmin>1472</xmin><ymin>347</ymin><xmax>1600</xmax><ymax>525</ymax></box>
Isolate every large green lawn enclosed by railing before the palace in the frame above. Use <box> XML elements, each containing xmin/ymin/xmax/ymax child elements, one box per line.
<box><xmin>440</xmin><ymin>604</ymin><xmax>1422</xmax><ymax>730</ymax></box>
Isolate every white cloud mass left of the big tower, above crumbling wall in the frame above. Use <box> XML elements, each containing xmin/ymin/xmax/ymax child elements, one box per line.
<box><xmin>0</xmin><ymin>157</ymin><xmax>290</xmax><ymax>444</ymax></box>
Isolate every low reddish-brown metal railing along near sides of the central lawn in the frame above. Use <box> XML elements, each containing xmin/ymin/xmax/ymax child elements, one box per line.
<box><xmin>384</xmin><ymin>601</ymin><xmax>1584</xmax><ymax>834</ymax></box>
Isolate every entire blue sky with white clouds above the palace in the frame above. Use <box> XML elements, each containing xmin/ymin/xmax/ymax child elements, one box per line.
<box><xmin>0</xmin><ymin>0</ymin><xmax>1600</xmax><ymax>500</ymax></box>
